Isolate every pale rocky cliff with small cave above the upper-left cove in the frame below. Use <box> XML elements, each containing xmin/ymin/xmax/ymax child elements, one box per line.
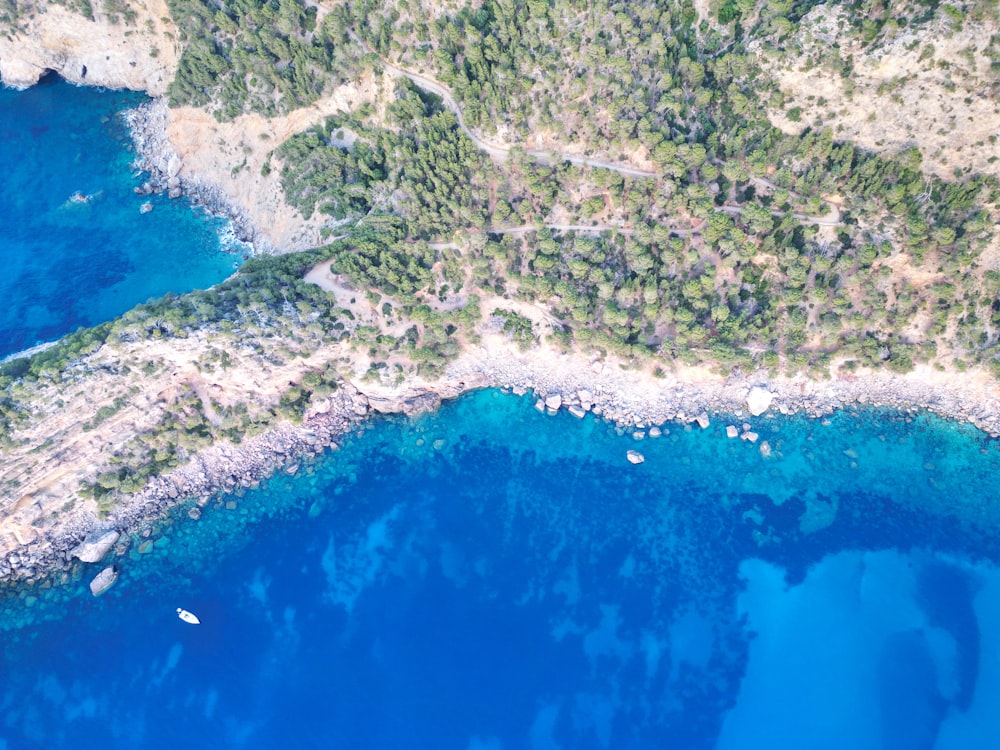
<box><xmin>0</xmin><ymin>0</ymin><xmax>181</xmax><ymax>96</ymax></box>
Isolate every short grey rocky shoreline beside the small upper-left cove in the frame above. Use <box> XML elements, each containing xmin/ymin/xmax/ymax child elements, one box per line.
<box><xmin>122</xmin><ymin>97</ymin><xmax>277</xmax><ymax>254</ymax></box>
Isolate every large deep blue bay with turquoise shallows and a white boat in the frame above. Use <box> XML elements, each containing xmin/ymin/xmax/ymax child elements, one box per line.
<box><xmin>0</xmin><ymin>391</ymin><xmax>1000</xmax><ymax>750</ymax></box>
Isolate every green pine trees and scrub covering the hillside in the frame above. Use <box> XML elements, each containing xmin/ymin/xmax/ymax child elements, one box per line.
<box><xmin>0</xmin><ymin>0</ymin><xmax>1000</xmax><ymax>512</ymax></box>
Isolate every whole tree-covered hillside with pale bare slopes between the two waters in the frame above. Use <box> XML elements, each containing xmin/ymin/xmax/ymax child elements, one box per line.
<box><xmin>0</xmin><ymin>0</ymin><xmax>1000</xmax><ymax>580</ymax></box>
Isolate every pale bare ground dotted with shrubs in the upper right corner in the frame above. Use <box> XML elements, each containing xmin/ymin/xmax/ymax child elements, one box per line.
<box><xmin>756</xmin><ymin>5</ymin><xmax>1000</xmax><ymax>180</ymax></box>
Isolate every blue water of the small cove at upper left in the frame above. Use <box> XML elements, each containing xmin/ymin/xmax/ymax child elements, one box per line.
<box><xmin>0</xmin><ymin>78</ymin><xmax>242</xmax><ymax>358</ymax></box>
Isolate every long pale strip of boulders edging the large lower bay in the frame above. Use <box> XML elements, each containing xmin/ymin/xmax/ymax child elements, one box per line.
<box><xmin>0</xmin><ymin>333</ymin><xmax>1000</xmax><ymax>589</ymax></box>
